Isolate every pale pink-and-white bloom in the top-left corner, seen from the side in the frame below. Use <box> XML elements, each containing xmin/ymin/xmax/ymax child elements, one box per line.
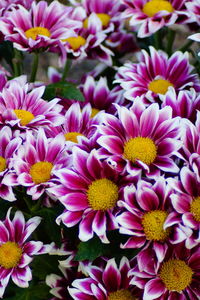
<box><xmin>0</xmin><ymin>1</ymin><xmax>80</xmax><ymax>54</ymax></box>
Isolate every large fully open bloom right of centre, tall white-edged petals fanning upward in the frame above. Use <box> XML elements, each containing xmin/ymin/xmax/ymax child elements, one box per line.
<box><xmin>97</xmin><ymin>99</ymin><xmax>181</xmax><ymax>177</ymax></box>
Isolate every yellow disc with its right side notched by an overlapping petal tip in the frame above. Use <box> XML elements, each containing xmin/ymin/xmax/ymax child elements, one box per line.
<box><xmin>142</xmin><ymin>210</ymin><xmax>170</xmax><ymax>241</ymax></box>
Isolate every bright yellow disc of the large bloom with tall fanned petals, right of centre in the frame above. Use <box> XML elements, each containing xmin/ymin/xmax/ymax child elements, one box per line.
<box><xmin>124</xmin><ymin>137</ymin><xmax>157</xmax><ymax>165</ymax></box>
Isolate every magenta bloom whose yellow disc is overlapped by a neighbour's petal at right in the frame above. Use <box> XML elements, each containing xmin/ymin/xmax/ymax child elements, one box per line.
<box><xmin>116</xmin><ymin>177</ymin><xmax>185</xmax><ymax>269</ymax></box>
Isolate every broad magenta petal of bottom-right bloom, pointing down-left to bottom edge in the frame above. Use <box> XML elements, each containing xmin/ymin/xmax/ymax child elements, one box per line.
<box><xmin>143</xmin><ymin>278</ymin><xmax>165</xmax><ymax>300</ymax></box>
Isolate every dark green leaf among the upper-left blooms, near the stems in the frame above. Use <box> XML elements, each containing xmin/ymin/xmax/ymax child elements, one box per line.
<box><xmin>43</xmin><ymin>82</ymin><xmax>85</xmax><ymax>101</ymax></box>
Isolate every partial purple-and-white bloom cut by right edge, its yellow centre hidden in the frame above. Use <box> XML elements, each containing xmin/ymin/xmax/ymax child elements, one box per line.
<box><xmin>180</xmin><ymin>111</ymin><xmax>200</xmax><ymax>181</ymax></box>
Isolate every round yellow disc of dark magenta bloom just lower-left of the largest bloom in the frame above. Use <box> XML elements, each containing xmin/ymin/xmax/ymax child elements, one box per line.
<box><xmin>87</xmin><ymin>178</ymin><xmax>118</xmax><ymax>210</ymax></box>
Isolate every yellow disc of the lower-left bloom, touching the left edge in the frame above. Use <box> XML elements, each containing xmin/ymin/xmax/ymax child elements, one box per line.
<box><xmin>0</xmin><ymin>242</ymin><xmax>22</xmax><ymax>269</ymax></box>
